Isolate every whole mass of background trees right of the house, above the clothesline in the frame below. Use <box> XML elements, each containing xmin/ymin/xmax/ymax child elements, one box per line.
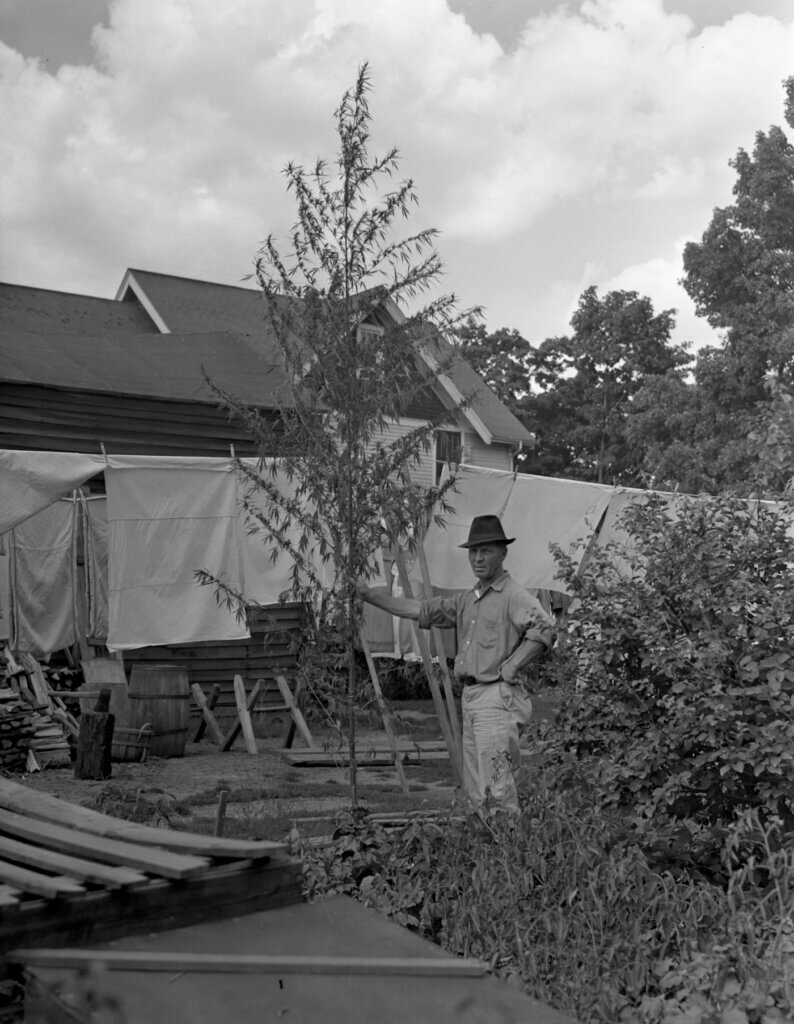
<box><xmin>459</xmin><ymin>78</ymin><xmax>794</xmax><ymax>497</ymax></box>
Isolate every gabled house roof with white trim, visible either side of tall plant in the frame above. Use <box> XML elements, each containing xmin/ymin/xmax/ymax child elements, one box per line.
<box><xmin>116</xmin><ymin>269</ymin><xmax>533</xmax><ymax>444</ymax></box>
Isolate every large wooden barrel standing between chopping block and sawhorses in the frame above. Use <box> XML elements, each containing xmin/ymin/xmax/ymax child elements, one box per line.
<box><xmin>127</xmin><ymin>664</ymin><xmax>191</xmax><ymax>758</ymax></box>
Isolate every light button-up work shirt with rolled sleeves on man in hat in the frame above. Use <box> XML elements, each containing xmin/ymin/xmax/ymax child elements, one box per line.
<box><xmin>418</xmin><ymin>572</ymin><xmax>554</xmax><ymax>683</ymax></box>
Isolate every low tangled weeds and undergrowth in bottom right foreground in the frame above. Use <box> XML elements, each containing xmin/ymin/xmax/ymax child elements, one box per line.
<box><xmin>304</xmin><ymin>774</ymin><xmax>794</xmax><ymax>1024</ymax></box>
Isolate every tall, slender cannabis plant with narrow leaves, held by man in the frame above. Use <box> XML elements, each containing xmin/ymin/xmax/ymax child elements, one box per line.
<box><xmin>207</xmin><ymin>65</ymin><xmax>470</xmax><ymax>803</ymax></box>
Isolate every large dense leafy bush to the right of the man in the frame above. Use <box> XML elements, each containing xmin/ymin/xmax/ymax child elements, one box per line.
<box><xmin>553</xmin><ymin>497</ymin><xmax>794</xmax><ymax>830</ymax></box>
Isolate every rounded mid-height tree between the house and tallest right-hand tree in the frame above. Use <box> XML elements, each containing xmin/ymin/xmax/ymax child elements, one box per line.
<box><xmin>526</xmin><ymin>287</ymin><xmax>689</xmax><ymax>483</ymax></box>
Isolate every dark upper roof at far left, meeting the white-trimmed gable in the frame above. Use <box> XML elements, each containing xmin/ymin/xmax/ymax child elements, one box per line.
<box><xmin>0</xmin><ymin>282</ymin><xmax>158</xmax><ymax>334</ymax></box>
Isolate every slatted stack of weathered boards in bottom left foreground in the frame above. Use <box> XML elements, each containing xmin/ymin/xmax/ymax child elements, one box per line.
<box><xmin>0</xmin><ymin>777</ymin><xmax>301</xmax><ymax>956</ymax></box>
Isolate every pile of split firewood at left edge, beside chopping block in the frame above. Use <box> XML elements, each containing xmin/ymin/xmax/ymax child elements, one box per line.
<box><xmin>3</xmin><ymin>648</ymin><xmax>74</xmax><ymax>770</ymax></box>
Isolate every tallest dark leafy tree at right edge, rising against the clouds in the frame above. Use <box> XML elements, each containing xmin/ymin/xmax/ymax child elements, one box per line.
<box><xmin>682</xmin><ymin>78</ymin><xmax>794</xmax><ymax>494</ymax></box>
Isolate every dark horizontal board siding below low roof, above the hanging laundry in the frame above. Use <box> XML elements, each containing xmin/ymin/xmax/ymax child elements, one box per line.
<box><xmin>0</xmin><ymin>384</ymin><xmax>270</xmax><ymax>456</ymax></box>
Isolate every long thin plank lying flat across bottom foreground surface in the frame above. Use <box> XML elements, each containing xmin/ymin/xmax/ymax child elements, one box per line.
<box><xmin>9</xmin><ymin>949</ymin><xmax>488</xmax><ymax>978</ymax></box>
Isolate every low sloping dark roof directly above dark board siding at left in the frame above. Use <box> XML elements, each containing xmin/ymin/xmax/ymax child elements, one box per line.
<box><xmin>0</xmin><ymin>329</ymin><xmax>283</xmax><ymax>407</ymax></box>
